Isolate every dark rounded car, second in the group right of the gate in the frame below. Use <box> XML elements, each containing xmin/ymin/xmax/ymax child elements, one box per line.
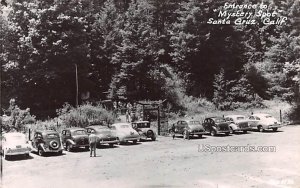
<box><xmin>202</xmin><ymin>117</ymin><xmax>230</xmax><ymax>136</ymax></box>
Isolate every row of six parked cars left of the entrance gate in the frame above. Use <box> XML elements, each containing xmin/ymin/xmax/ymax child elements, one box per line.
<box><xmin>0</xmin><ymin>121</ymin><xmax>156</xmax><ymax>159</ymax></box>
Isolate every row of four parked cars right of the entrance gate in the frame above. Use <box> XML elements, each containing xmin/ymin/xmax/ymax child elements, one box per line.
<box><xmin>169</xmin><ymin>113</ymin><xmax>281</xmax><ymax>139</ymax></box>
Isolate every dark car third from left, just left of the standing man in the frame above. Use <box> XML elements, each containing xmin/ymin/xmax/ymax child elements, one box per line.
<box><xmin>61</xmin><ymin>127</ymin><xmax>89</xmax><ymax>151</ymax></box>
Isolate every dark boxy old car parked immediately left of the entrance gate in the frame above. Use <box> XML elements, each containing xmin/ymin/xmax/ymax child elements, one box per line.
<box><xmin>131</xmin><ymin>121</ymin><xmax>156</xmax><ymax>141</ymax></box>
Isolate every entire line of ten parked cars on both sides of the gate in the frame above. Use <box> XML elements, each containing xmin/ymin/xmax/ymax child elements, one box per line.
<box><xmin>0</xmin><ymin>114</ymin><xmax>281</xmax><ymax>158</ymax></box>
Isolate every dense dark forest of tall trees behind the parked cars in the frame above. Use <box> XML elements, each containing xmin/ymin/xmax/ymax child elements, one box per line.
<box><xmin>0</xmin><ymin>0</ymin><xmax>300</xmax><ymax>119</ymax></box>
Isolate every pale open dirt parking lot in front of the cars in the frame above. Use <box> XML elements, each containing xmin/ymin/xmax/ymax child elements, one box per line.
<box><xmin>1</xmin><ymin>126</ymin><xmax>300</xmax><ymax>188</ymax></box>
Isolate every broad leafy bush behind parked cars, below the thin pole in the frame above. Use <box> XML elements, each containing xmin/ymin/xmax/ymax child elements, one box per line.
<box><xmin>57</xmin><ymin>103</ymin><xmax>115</xmax><ymax>127</ymax></box>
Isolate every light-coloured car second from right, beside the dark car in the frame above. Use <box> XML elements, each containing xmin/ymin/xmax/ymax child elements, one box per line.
<box><xmin>225</xmin><ymin>115</ymin><xmax>252</xmax><ymax>134</ymax></box>
